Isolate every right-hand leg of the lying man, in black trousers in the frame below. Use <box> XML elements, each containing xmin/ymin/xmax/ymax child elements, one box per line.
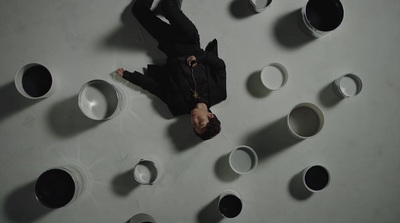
<box><xmin>162</xmin><ymin>0</ymin><xmax>200</xmax><ymax>44</ymax></box>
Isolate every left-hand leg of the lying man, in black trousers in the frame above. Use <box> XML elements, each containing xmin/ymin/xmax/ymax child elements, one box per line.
<box><xmin>132</xmin><ymin>0</ymin><xmax>172</xmax><ymax>42</ymax></box>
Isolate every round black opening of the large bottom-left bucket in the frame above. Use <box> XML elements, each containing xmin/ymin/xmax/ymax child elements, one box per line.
<box><xmin>35</xmin><ymin>169</ymin><xmax>75</xmax><ymax>208</ymax></box>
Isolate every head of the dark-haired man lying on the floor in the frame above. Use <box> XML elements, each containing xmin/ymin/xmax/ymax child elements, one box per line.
<box><xmin>190</xmin><ymin>107</ymin><xmax>221</xmax><ymax>140</ymax></box>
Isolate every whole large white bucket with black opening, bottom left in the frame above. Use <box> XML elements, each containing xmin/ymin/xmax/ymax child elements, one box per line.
<box><xmin>35</xmin><ymin>164</ymin><xmax>87</xmax><ymax>208</ymax></box>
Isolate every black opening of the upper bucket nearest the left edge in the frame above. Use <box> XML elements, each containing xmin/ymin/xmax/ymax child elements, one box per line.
<box><xmin>22</xmin><ymin>65</ymin><xmax>53</xmax><ymax>97</ymax></box>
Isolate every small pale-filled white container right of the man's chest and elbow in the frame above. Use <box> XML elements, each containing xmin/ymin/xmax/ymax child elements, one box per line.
<box><xmin>260</xmin><ymin>63</ymin><xmax>288</xmax><ymax>91</ymax></box>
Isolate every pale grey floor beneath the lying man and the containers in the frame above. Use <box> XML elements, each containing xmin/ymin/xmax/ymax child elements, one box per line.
<box><xmin>0</xmin><ymin>0</ymin><xmax>400</xmax><ymax>223</ymax></box>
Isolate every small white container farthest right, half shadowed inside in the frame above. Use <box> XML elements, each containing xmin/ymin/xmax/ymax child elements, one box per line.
<box><xmin>333</xmin><ymin>73</ymin><xmax>362</xmax><ymax>98</ymax></box>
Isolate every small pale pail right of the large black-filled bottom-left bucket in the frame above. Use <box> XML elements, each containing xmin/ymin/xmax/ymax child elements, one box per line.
<box><xmin>133</xmin><ymin>160</ymin><xmax>158</xmax><ymax>185</ymax></box>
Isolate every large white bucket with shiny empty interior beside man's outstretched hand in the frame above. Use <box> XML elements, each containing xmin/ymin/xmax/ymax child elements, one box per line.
<box><xmin>78</xmin><ymin>80</ymin><xmax>125</xmax><ymax>121</ymax></box>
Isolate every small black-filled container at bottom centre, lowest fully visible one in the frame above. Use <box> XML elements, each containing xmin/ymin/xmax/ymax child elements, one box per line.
<box><xmin>218</xmin><ymin>190</ymin><xmax>243</xmax><ymax>218</ymax></box>
